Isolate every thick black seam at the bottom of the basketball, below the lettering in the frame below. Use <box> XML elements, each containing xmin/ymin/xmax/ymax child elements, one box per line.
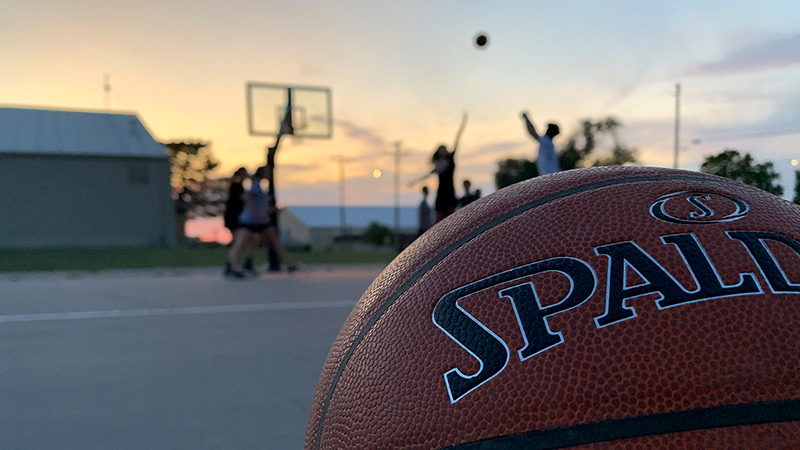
<box><xmin>444</xmin><ymin>400</ymin><xmax>800</xmax><ymax>450</ymax></box>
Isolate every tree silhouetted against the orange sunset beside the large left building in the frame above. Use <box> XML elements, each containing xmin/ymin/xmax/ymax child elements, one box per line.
<box><xmin>164</xmin><ymin>142</ymin><xmax>227</xmax><ymax>218</ymax></box>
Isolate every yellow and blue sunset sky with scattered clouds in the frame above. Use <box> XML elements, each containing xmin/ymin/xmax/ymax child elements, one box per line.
<box><xmin>0</xmin><ymin>0</ymin><xmax>800</xmax><ymax>205</ymax></box>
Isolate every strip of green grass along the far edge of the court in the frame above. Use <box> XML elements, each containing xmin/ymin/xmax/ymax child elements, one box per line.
<box><xmin>0</xmin><ymin>246</ymin><xmax>396</xmax><ymax>272</ymax></box>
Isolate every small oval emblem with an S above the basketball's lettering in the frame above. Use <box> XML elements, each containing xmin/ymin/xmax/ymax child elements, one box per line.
<box><xmin>650</xmin><ymin>191</ymin><xmax>750</xmax><ymax>224</ymax></box>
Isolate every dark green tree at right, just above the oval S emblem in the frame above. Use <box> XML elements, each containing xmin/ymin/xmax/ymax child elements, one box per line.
<box><xmin>700</xmin><ymin>149</ymin><xmax>783</xmax><ymax>195</ymax></box>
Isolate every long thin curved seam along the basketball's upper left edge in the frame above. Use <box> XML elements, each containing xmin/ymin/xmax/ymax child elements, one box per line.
<box><xmin>314</xmin><ymin>175</ymin><xmax>742</xmax><ymax>450</ymax></box>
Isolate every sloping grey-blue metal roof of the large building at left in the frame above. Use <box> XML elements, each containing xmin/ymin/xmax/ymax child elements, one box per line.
<box><xmin>0</xmin><ymin>107</ymin><xmax>169</xmax><ymax>159</ymax></box>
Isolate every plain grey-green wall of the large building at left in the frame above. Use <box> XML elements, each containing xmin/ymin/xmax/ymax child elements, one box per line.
<box><xmin>0</xmin><ymin>154</ymin><xmax>175</xmax><ymax>248</ymax></box>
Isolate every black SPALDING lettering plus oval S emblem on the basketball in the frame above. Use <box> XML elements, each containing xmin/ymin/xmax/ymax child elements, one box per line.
<box><xmin>432</xmin><ymin>191</ymin><xmax>800</xmax><ymax>403</ymax></box>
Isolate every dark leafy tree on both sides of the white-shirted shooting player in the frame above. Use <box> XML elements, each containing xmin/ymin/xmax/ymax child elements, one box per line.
<box><xmin>494</xmin><ymin>117</ymin><xmax>637</xmax><ymax>189</ymax></box>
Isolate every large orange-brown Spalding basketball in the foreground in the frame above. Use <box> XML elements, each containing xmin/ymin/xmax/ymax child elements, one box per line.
<box><xmin>305</xmin><ymin>167</ymin><xmax>800</xmax><ymax>450</ymax></box>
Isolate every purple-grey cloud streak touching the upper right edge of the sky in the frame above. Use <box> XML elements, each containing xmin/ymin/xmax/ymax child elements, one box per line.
<box><xmin>687</xmin><ymin>34</ymin><xmax>800</xmax><ymax>75</ymax></box>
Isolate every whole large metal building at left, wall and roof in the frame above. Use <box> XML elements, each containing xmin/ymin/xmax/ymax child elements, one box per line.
<box><xmin>0</xmin><ymin>107</ymin><xmax>175</xmax><ymax>248</ymax></box>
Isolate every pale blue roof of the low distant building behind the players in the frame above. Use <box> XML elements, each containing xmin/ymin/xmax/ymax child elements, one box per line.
<box><xmin>286</xmin><ymin>206</ymin><xmax>419</xmax><ymax>229</ymax></box>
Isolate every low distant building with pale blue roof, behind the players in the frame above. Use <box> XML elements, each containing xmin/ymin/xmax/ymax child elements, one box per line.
<box><xmin>278</xmin><ymin>206</ymin><xmax>419</xmax><ymax>251</ymax></box>
